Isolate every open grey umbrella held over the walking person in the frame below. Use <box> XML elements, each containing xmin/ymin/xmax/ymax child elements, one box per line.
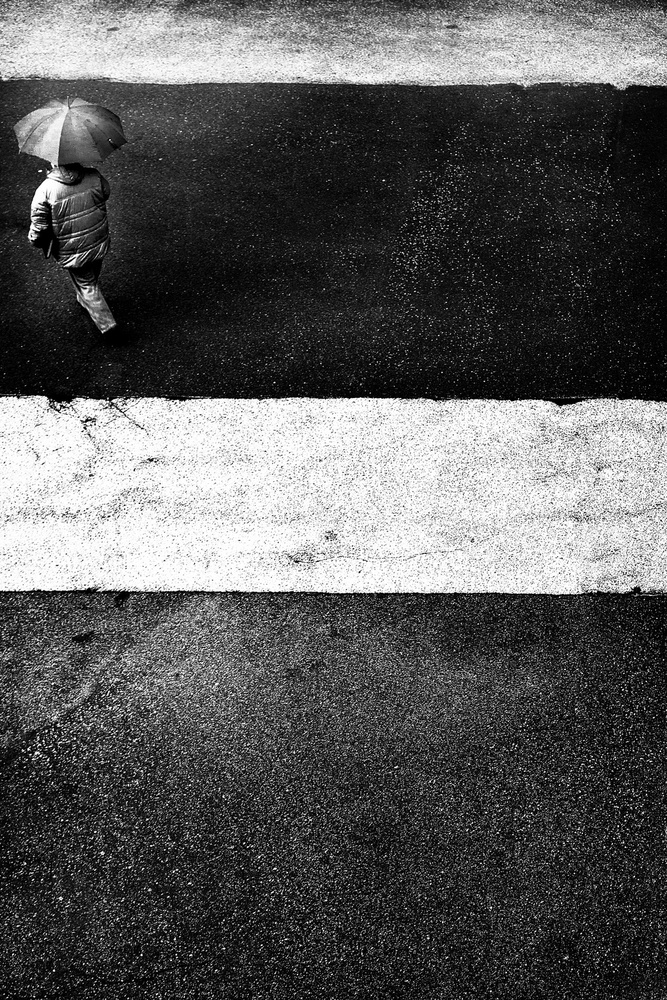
<box><xmin>14</xmin><ymin>97</ymin><xmax>127</xmax><ymax>163</ymax></box>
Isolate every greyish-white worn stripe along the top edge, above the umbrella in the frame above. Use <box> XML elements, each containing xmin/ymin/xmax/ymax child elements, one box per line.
<box><xmin>0</xmin><ymin>0</ymin><xmax>667</xmax><ymax>87</ymax></box>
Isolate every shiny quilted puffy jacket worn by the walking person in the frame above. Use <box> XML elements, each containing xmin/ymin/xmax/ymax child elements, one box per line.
<box><xmin>28</xmin><ymin>164</ymin><xmax>111</xmax><ymax>267</ymax></box>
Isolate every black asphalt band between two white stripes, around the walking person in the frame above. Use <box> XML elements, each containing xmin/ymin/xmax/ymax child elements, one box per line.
<box><xmin>0</xmin><ymin>80</ymin><xmax>667</xmax><ymax>399</ymax></box>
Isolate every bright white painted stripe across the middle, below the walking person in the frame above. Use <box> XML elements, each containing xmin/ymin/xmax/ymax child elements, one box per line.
<box><xmin>0</xmin><ymin>397</ymin><xmax>667</xmax><ymax>593</ymax></box>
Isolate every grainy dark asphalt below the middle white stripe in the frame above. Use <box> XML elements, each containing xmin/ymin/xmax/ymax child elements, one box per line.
<box><xmin>0</xmin><ymin>593</ymin><xmax>667</xmax><ymax>1000</ymax></box>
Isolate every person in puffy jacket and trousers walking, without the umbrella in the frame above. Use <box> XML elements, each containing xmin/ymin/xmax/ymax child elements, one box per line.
<box><xmin>28</xmin><ymin>163</ymin><xmax>117</xmax><ymax>334</ymax></box>
